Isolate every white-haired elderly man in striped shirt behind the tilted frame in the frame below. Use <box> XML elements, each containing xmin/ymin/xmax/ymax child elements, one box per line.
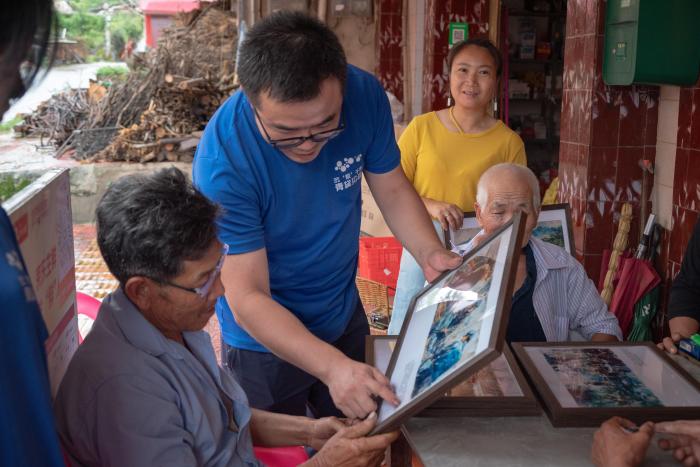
<box><xmin>389</xmin><ymin>163</ymin><xmax>622</xmax><ymax>342</ymax></box>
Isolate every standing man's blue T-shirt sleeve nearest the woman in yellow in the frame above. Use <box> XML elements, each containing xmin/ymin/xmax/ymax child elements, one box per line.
<box><xmin>365</xmin><ymin>76</ymin><xmax>401</xmax><ymax>174</ymax></box>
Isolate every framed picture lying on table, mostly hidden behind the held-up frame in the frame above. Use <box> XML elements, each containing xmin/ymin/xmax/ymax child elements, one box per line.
<box><xmin>365</xmin><ymin>336</ymin><xmax>541</xmax><ymax>417</ymax></box>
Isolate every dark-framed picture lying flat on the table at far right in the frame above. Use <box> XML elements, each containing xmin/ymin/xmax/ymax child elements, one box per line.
<box><xmin>513</xmin><ymin>342</ymin><xmax>700</xmax><ymax>427</ymax></box>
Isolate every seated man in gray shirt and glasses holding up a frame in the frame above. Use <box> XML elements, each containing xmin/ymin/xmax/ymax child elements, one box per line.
<box><xmin>54</xmin><ymin>168</ymin><xmax>396</xmax><ymax>466</ymax></box>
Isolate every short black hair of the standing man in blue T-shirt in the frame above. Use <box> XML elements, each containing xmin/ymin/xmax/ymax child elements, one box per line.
<box><xmin>238</xmin><ymin>11</ymin><xmax>347</xmax><ymax>104</ymax></box>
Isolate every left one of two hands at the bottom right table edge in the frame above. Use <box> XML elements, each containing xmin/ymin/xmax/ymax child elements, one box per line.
<box><xmin>591</xmin><ymin>417</ymin><xmax>654</xmax><ymax>467</ymax></box>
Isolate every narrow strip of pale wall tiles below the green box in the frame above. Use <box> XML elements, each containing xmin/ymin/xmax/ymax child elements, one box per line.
<box><xmin>652</xmin><ymin>86</ymin><xmax>680</xmax><ymax>229</ymax></box>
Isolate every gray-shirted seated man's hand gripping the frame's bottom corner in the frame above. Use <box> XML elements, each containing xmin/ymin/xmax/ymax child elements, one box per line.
<box><xmin>304</xmin><ymin>412</ymin><xmax>399</xmax><ymax>467</ymax></box>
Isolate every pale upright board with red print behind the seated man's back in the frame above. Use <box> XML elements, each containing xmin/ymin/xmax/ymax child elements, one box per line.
<box><xmin>3</xmin><ymin>169</ymin><xmax>78</xmax><ymax>394</ymax></box>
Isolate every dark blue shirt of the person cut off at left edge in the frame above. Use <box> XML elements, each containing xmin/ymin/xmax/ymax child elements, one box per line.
<box><xmin>0</xmin><ymin>207</ymin><xmax>64</xmax><ymax>466</ymax></box>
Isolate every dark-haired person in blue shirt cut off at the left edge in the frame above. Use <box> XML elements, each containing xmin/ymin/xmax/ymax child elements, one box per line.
<box><xmin>0</xmin><ymin>0</ymin><xmax>64</xmax><ymax>467</ymax></box>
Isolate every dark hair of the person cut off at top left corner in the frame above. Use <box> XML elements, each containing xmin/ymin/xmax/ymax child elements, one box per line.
<box><xmin>0</xmin><ymin>0</ymin><xmax>58</xmax><ymax>97</ymax></box>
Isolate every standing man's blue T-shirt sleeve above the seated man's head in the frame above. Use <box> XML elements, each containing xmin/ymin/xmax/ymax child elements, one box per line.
<box><xmin>192</xmin><ymin>106</ymin><xmax>265</xmax><ymax>254</ymax></box>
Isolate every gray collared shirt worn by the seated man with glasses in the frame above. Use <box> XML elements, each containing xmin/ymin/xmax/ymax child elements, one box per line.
<box><xmin>54</xmin><ymin>289</ymin><xmax>261</xmax><ymax>467</ymax></box>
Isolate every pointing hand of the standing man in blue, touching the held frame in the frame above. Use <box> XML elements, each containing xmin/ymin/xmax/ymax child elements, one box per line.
<box><xmin>324</xmin><ymin>357</ymin><xmax>399</xmax><ymax>418</ymax></box>
